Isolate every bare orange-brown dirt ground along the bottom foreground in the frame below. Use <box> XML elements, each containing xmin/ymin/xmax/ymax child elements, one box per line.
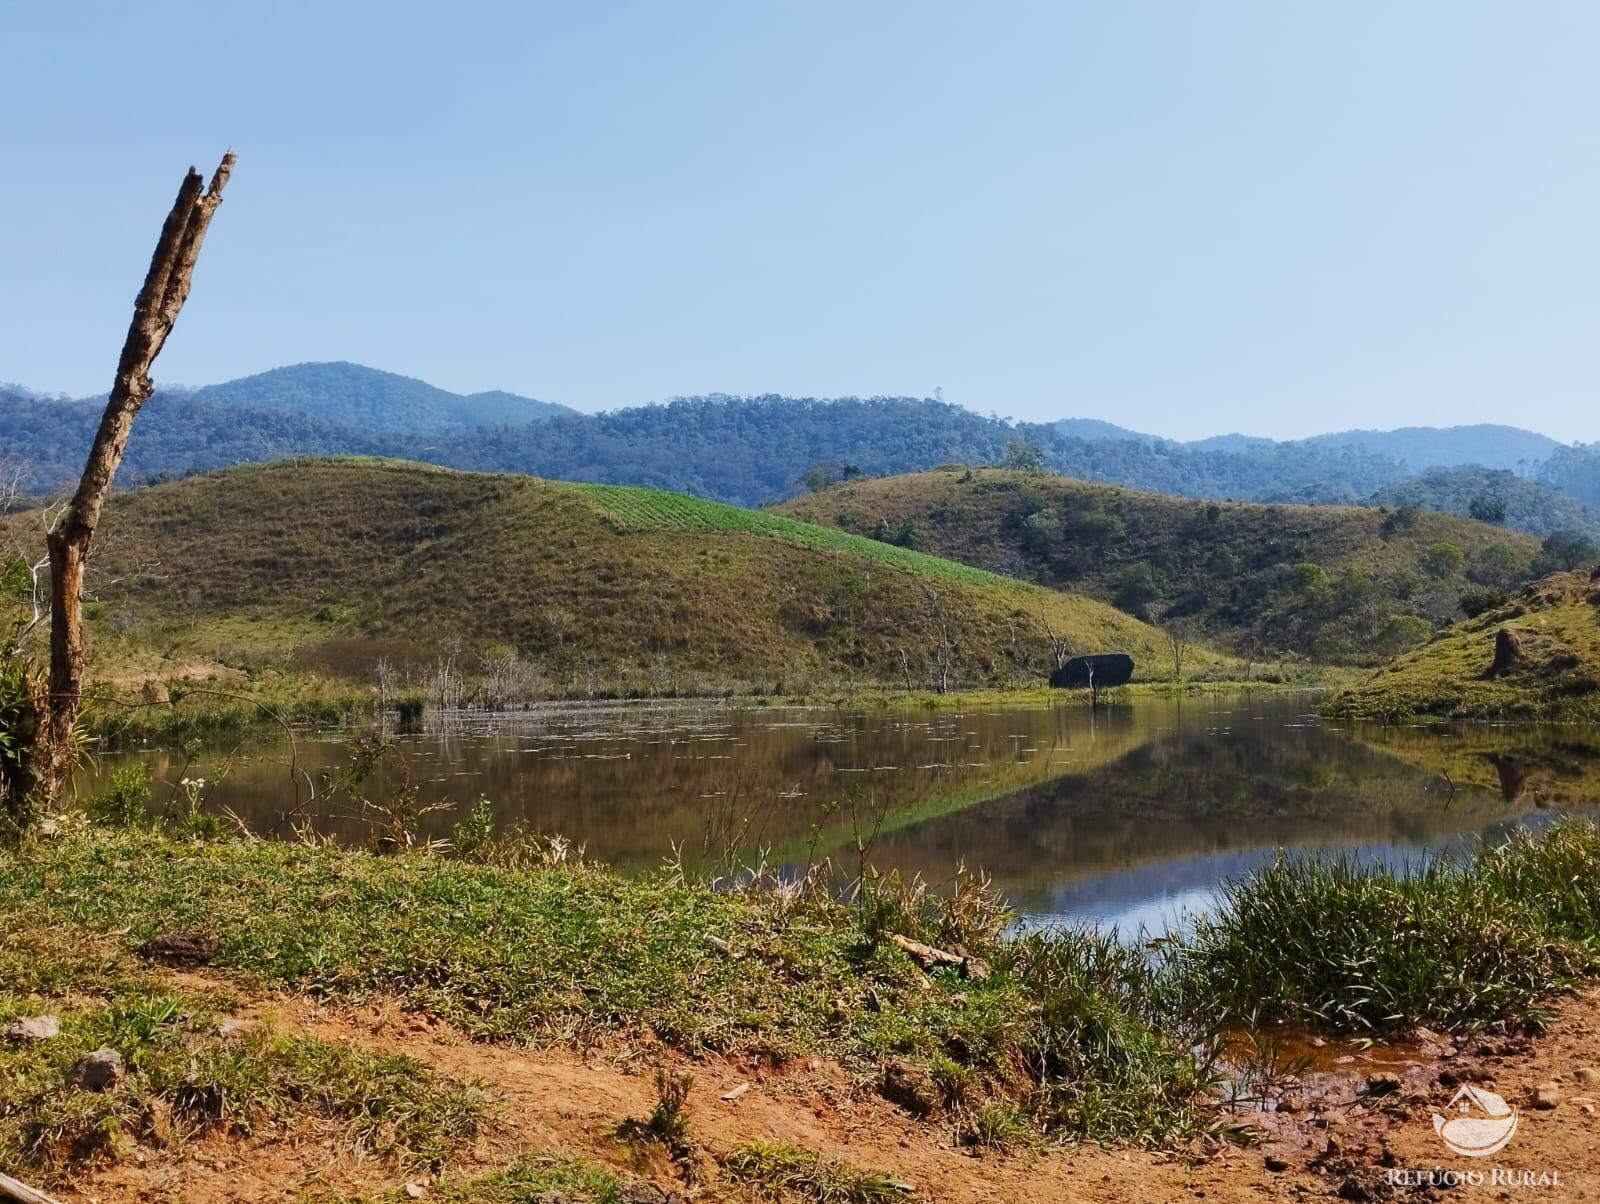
<box><xmin>43</xmin><ymin>973</ymin><xmax>1600</xmax><ymax>1204</ymax></box>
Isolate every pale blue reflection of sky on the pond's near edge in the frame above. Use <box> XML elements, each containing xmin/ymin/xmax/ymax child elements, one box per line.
<box><xmin>1018</xmin><ymin>812</ymin><xmax>1580</xmax><ymax>937</ymax></box>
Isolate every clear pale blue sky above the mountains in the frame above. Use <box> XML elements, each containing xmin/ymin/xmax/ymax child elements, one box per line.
<box><xmin>0</xmin><ymin>0</ymin><xmax>1600</xmax><ymax>440</ymax></box>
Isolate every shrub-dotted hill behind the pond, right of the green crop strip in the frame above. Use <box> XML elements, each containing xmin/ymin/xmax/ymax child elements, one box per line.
<box><xmin>781</xmin><ymin>468</ymin><xmax>1539</xmax><ymax>663</ymax></box>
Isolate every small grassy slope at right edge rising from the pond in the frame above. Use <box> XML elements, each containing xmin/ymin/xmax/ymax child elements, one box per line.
<box><xmin>1328</xmin><ymin>570</ymin><xmax>1600</xmax><ymax>720</ymax></box>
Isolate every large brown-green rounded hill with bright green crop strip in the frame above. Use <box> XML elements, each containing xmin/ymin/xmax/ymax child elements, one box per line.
<box><xmin>15</xmin><ymin>460</ymin><xmax>1218</xmax><ymax>695</ymax></box>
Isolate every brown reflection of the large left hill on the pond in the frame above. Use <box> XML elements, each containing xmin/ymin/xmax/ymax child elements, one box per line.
<box><xmin>104</xmin><ymin>703</ymin><xmax>1171</xmax><ymax>866</ymax></box>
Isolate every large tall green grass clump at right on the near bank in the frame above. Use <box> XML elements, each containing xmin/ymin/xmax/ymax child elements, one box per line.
<box><xmin>1174</xmin><ymin>821</ymin><xmax>1600</xmax><ymax>1034</ymax></box>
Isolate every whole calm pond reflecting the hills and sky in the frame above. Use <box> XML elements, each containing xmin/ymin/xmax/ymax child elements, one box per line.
<box><xmin>86</xmin><ymin>695</ymin><xmax>1600</xmax><ymax>932</ymax></box>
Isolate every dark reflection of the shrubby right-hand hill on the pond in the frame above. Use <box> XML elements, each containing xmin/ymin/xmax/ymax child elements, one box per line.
<box><xmin>838</xmin><ymin>703</ymin><xmax>1561</xmax><ymax>913</ymax></box>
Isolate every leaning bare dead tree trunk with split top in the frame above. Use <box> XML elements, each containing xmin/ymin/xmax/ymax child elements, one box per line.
<box><xmin>35</xmin><ymin>151</ymin><xmax>234</xmax><ymax>805</ymax></box>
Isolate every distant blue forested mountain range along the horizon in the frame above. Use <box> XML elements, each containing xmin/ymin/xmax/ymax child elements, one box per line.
<box><xmin>0</xmin><ymin>363</ymin><xmax>1600</xmax><ymax>536</ymax></box>
